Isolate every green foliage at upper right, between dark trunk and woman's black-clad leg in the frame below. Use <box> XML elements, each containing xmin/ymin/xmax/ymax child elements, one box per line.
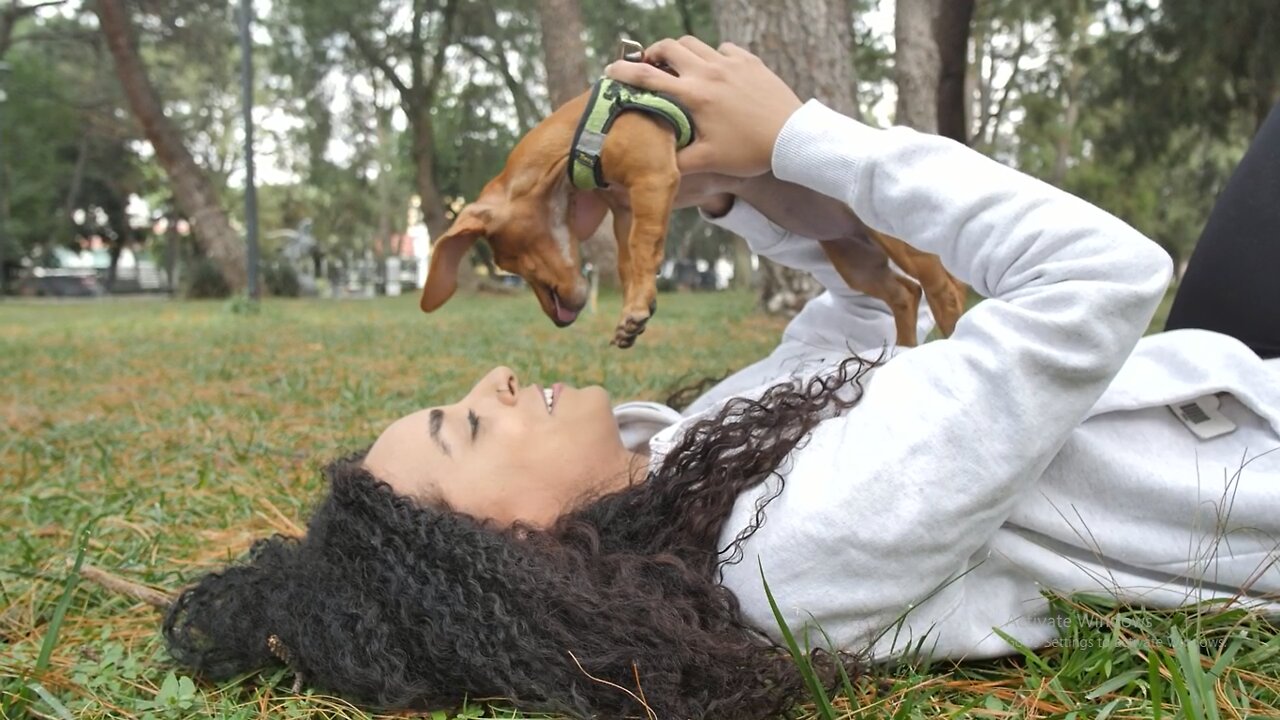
<box><xmin>974</xmin><ymin>0</ymin><xmax>1280</xmax><ymax>269</ymax></box>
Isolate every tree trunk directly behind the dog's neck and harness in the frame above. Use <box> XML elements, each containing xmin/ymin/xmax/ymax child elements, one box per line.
<box><xmin>538</xmin><ymin>0</ymin><xmax>620</xmax><ymax>288</ymax></box>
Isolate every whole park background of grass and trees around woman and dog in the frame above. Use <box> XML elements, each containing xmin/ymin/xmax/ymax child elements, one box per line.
<box><xmin>0</xmin><ymin>0</ymin><xmax>1280</xmax><ymax>717</ymax></box>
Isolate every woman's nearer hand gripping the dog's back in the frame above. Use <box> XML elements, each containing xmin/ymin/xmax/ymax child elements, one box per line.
<box><xmin>604</xmin><ymin>36</ymin><xmax>801</xmax><ymax>177</ymax></box>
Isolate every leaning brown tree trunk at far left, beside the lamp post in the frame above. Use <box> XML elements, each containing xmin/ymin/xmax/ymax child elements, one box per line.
<box><xmin>96</xmin><ymin>0</ymin><xmax>247</xmax><ymax>290</ymax></box>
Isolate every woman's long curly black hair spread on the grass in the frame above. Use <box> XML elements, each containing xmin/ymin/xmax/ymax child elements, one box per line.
<box><xmin>164</xmin><ymin>357</ymin><xmax>877</xmax><ymax>719</ymax></box>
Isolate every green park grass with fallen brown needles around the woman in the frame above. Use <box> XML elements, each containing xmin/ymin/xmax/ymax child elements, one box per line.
<box><xmin>0</xmin><ymin>286</ymin><xmax>1280</xmax><ymax>720</ymax></box>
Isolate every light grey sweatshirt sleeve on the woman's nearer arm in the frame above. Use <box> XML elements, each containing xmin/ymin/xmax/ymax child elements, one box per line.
<box><xmin>726</xmin><ymin>101</ymin><xmax>1171</xmax><ymax>650</ymax></box>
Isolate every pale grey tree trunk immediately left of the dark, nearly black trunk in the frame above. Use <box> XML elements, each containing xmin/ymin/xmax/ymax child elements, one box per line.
<box><xmin>893</xmin><ymin>0</ymin><xmax>950</xmax><ymax>132</ymax></box>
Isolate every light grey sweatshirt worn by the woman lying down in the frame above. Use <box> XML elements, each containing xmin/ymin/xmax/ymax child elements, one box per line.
<box><xmin>616</xmin><ymin>101</ymin><xmax>1280</xmax><ymax>659</ymax></box>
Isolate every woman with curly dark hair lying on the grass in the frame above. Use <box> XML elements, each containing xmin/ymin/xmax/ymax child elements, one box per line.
<box><xmin>165</xmin><ymin>38</ymin><xmax>1280</xmax><ymax>719</ymax></box>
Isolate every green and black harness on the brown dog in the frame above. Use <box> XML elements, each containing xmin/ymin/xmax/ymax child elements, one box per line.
<box><xmin>568</xmin><ymin>78</ymin><xmax>694</xmax><ymax>190</ymax></box>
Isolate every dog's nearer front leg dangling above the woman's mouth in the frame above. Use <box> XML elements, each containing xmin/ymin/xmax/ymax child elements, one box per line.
<box><xmin>613</xmin><ymin>174</ymin><xmax>680</xmax><ymax>348</ymax></box>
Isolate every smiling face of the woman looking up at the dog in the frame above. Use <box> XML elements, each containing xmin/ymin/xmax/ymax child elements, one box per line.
<box><xmin>365</xmin><ymin>368</ymin><xmax>644</xmax><ymax>527</ymax></box>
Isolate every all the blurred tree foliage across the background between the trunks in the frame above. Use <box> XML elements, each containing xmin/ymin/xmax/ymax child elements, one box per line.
<box><xmin>3</xmin><ymin>0</ymin><xmax>1280</xmax><ymax>278</ymax></box>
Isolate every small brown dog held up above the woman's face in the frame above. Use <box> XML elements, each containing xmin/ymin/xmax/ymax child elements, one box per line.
<box><xmin>421</xmin><ymin>84</ymin><xmax>964</xmax><ymax>347</ymax></box>
